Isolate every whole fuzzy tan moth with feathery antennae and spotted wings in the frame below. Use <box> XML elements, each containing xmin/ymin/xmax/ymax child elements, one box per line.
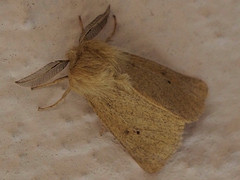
<box><xmin>16</xmin><ymin>6</ymin><xmax>208</xmax><ymax>173</ymax></box>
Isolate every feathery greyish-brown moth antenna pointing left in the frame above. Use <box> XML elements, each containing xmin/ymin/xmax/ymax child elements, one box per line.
<box><xmin>16</xmin><ymin>60</ymin><xmax>69</xmax><ymax>87</ymax></box>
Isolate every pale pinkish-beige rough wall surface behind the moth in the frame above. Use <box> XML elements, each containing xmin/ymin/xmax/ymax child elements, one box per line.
<box><xmin>0</xmin><ymin>0</ymin><xmax>240</xmax><ymax>180</ymax></box>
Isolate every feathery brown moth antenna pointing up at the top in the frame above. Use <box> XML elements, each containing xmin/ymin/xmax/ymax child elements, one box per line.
<box><xmin>79</xmin><ymin>5</ymin><xmax>110</xmax><ymax>43</ymax></box>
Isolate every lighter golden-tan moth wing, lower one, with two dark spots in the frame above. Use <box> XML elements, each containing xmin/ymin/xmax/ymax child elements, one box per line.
<box><xmin>87</xmin><ymin>89</ymin><xmax>185</xmax><ymax>173</ymax></box>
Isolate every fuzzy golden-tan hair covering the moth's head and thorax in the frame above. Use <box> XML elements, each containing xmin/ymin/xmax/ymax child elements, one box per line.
<box><xmin>67</xmin><ymin>40</ymin><xmax>129</xmax><ymax>96</ymax></box>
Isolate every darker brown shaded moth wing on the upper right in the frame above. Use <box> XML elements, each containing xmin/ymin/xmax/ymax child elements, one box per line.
<box><xmin>118</xmin><ymin>53</ymin><xmax>208</xmax><ymax>122</ymax></box>
